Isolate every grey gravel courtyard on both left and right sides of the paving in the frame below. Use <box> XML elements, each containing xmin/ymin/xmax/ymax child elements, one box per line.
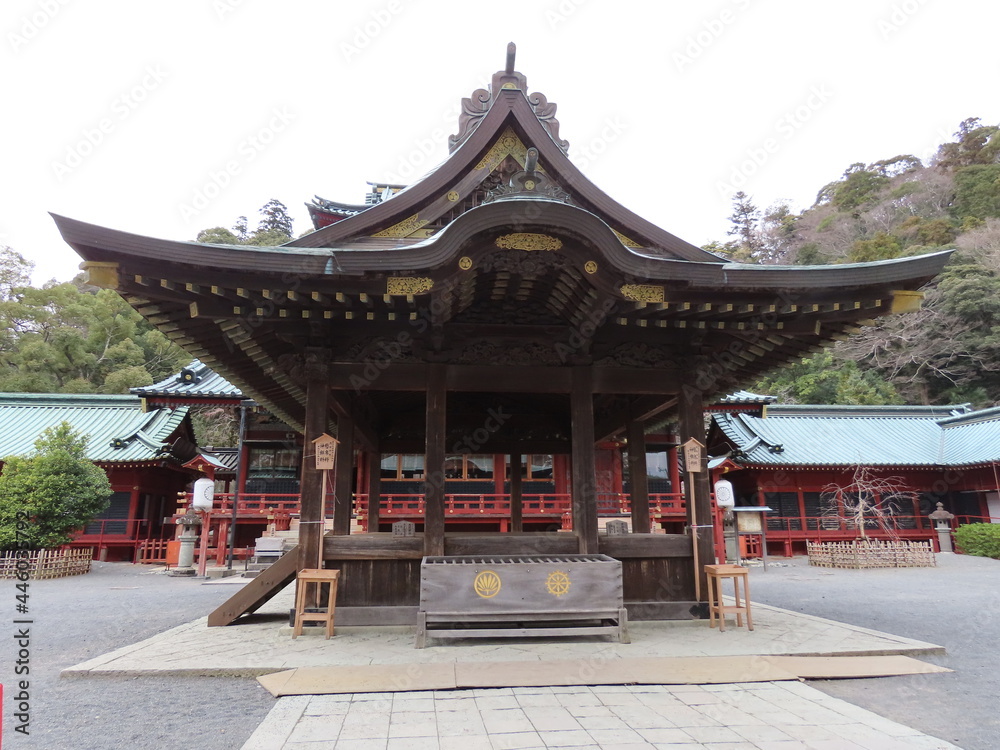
<box><xmin>0</xmin><ymin>555</ymin><xmax>1000</xmax><ymax>750</ymax></box>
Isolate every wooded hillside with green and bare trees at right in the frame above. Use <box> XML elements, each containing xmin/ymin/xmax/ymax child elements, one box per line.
<box><xmin>706</xmin><ymin>118</ymin><xmax>1000</xmax><ymax>407</ymax></box>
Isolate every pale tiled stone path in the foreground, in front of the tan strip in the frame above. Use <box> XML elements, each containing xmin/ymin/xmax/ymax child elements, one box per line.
<box><xmin>243</xmin><ymin>682</ymin><xmax>956</xmax><ymax>750</ymax></box>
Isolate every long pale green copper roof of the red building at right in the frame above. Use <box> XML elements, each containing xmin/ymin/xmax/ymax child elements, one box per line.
<box><xmin>713</xmin><ymin>404</ymin><xmax>1000</xmax><ymax>466</ymax></box>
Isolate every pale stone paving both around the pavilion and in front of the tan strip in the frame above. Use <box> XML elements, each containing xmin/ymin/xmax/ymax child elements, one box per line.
<box><xmin>63</xmin><ymin>584</ymin><xmax>955</xmax><ymax>750</ymax></box>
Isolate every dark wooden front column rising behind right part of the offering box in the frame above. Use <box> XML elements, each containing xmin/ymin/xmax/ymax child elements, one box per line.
<box><xmin>570</xmin><ymin>367</ymin><xmax>597</xmax><ymax>554</ymax></box>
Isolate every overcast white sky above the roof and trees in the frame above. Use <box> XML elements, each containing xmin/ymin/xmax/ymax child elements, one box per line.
<box><xmin>0</xmin><ymin>0</ymin><xmax>1000</xmax><ymax>282</ymax></box>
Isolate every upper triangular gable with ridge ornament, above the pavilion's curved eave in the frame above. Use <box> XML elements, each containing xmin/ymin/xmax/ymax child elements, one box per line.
<box><xmin>285</xmin><ymin>46</ymin><xmax>726</xmax><ymax>265</ymax></box>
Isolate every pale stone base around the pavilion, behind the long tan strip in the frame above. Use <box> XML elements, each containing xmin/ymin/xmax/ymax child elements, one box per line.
<box><xmin>62</xmin><ymin>587</ymin><xmax>944</xmax><ymax>677</ymax></box>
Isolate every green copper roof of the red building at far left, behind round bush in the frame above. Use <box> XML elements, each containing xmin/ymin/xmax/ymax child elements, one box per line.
<box><xmin>0</xmin><ymin>393</ymin><xmax>194</xmax><ymax>463</ymax></box>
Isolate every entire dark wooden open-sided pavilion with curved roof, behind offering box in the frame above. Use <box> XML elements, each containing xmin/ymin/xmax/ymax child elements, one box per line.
<box><xmin>55</xmin><ymin>45</ymin><xmax>948</xmax><ymax>624</ymax></box>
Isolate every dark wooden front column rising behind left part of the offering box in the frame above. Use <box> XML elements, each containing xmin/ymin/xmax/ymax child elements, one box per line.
<box><xmin>424</xmin><ymin>365</ymin><xmax>448</xmax><ymax>555</ymax></box>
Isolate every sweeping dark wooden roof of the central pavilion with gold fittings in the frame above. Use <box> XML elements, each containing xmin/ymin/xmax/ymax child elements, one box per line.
<box><xmin>54</xmin><ymin>52</ymin><xmax>948</xmax><ymax>434</ymax></box>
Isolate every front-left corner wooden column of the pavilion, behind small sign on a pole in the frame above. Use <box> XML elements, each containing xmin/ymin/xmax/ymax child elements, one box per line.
<box><xmin>299</xmin><ymin>351</ymin><xmax>330</xmax><ymax>570</ymax></box>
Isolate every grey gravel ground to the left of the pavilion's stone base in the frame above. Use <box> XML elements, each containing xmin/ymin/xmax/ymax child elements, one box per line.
<box><xmin>0</xmin><ymin>563</ymin><xmax>274</xmax><ymax>750</ymax></box>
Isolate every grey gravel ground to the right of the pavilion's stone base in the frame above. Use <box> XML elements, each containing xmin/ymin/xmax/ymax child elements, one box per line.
<box><xmin>750</xmin><ymin>555</ymin><xmax>1000</xmax><ymax>750</ymax></box>
